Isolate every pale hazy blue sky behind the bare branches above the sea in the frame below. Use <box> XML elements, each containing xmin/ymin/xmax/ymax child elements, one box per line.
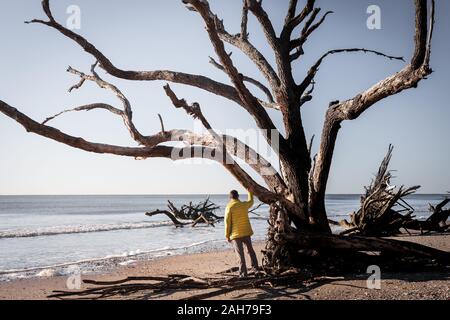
<box><xmin>0</xmin><ymin>0</ymin><xmax>450</xmax><ymax>194</ymax></box>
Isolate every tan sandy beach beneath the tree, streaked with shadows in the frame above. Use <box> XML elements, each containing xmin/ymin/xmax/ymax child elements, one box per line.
<box><xmin>0</xmin><ymin>234</ymin><xmax>450</xmax><ymax>300</ymax></box>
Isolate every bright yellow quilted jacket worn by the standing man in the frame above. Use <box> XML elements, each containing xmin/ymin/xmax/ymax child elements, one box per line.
<box><xmin>225</xmin><ymin>192</ymin><xmax>253</xmax><ymax>240</ymax></box>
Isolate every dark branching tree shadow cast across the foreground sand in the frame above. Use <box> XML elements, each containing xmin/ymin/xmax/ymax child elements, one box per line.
<box><xmin>47</xmin><ymin>268</ymin><xmax>450</xmax><ymax>300</ymax></box>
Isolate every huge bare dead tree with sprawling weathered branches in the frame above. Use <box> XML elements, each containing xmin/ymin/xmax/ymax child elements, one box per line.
<box><xmin>0</xmin><ymin>0</ymin><xmax>444</xmax><ymax>268</ymax></box>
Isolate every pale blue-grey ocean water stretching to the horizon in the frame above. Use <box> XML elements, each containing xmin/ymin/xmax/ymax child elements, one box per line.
<box><xmin>0</xmin><ymin>195</ymin><xmax>443</xmax><ymax>281</ymax></box>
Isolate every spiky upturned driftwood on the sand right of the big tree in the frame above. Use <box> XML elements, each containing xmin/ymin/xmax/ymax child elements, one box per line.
<box><xmin>339</xmin><ymin>145</ymin><xmax>450</xmax><ymax>236</ymax></box>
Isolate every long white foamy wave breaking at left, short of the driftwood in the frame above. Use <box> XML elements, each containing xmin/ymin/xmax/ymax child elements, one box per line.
<box><xmin>0</xmin><ymin>221</ymin><xmax>178</xmax><ymax>239</ymax></box>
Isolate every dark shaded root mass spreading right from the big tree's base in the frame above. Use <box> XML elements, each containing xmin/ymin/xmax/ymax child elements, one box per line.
<box><xmin>263</xmin><ymin>232</ymin><xmax>450</xmax><ymax>275</ymax></box>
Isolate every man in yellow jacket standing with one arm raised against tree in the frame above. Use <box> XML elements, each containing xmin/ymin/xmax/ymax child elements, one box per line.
<box><xmin>225</xmin><ymin>190</ymin><xmax>258</xmax><ymax>277</ymax></box>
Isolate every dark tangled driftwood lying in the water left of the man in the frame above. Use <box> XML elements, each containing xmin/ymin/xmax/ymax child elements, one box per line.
<box><xmin>145</xmin><ymin>198</ymin><xmax>223</xmax><ymax>228</ymax></box>
